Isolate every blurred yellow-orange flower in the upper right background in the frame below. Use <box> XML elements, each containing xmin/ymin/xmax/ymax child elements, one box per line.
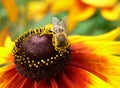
<box><xmin>51</xmin><ymin>0</ymin><xmax>120</xmax><ymax>32</ymax></box>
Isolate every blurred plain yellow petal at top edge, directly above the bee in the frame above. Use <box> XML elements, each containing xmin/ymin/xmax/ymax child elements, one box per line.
<box><xmin>51</xmin><ymin>0</ymin><xmax>75</xmax><ymax>14</ymax></box>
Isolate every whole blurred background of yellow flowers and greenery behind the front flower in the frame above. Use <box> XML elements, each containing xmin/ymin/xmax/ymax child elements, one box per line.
<box><xmin>0</xmin><ymin>0</ymin><xmax>120</xmax><ymax>41</ymax></box>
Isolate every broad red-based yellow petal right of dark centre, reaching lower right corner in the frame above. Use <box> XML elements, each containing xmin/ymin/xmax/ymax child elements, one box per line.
<box><xmin>71</xmin><ymin>42</ymin><xmax>120</xmax><ymax>88</ymax></box>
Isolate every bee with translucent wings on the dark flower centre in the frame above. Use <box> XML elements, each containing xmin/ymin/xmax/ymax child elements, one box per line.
<box><xmin>52</xmin><ymin>17</ymin><xmax>67</xmax><ymax>47</ymax></box>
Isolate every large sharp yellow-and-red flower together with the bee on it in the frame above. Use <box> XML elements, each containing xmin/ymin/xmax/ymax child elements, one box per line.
<box><xmin>0</xmin><ymin>18</ymin><xmax>120</xmax><ymax>88</ymax></box>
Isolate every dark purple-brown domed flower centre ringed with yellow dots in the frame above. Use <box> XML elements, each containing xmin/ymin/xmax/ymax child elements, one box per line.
<box><xmin>13</xmin><ymin>28</ymin><xmax>71</xmax><ymax>81</ymax></box>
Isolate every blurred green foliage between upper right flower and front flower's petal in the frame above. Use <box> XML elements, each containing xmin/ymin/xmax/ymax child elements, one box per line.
<box><xmin>71</xmin><ymin>12</ymin><xmax>119</xmax><ymax>35</ymax></box>
